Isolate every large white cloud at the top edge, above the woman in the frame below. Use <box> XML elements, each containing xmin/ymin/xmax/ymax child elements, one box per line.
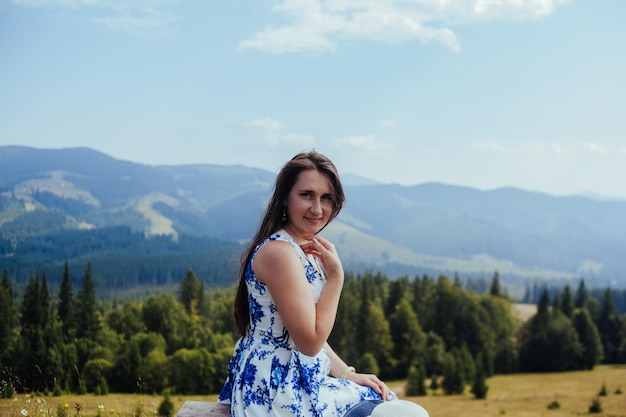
<box><xmin>240</xmin><ymin>0</ymin><xmax>571</xmax><ymax>53</ymax></box>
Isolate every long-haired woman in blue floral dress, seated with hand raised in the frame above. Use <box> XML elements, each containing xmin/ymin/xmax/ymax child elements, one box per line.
<box><xmin>219</xmin><ymin>151</ymin><xmax>427</xmax><ymax>417</ymax></box>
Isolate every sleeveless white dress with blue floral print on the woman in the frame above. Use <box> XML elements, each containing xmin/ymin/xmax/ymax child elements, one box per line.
<box><xmin>219</xmin><ymin>230</ymin><xmax>381</xmax><ymax>417</ymax></box>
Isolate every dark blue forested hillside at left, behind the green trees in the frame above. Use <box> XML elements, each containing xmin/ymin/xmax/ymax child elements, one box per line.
<box><xmin>0</xmin><ymin>226</ymin><xmax>241</xmax><ymax>290</ymax></box>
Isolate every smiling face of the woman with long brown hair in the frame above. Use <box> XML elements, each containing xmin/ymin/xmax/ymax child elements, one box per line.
<box><xmin>285</xmin><ymin>169</ymin><xmax>333</xmax><ymax>243</ymax></box>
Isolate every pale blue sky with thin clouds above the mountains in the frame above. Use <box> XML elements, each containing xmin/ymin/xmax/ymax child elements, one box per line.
<box><xmin>0</xmin><ymin>0</ymin><xmax>626</xmax><ymax>198</ymax></box>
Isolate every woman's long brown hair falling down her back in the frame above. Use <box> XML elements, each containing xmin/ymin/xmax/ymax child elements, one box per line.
<box><xmin>234</xmin><ymin>150</ymin><xmax>345</xmax><ymax>336</ymax></box>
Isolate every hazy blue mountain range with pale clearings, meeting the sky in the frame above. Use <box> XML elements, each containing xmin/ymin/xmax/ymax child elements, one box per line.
<box><xmin>0</xmin><ymin>146</ymin><xmax>626</xmax><ymax>287</ymax></box>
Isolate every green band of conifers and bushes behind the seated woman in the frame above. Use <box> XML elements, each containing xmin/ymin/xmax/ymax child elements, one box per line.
<box><xmin>0</xmin><ymin>262</ymin><xmax>626</xmax><ymax>397</ymax></box>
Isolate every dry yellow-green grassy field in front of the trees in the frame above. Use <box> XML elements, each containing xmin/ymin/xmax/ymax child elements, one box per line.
<box><xmin>0</xmin><ymin>366</ymin><xmax>626</xmax><ymax>417</ymax></box>
